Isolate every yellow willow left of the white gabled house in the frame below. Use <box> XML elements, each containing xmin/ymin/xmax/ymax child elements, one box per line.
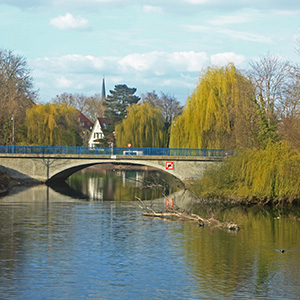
<box><xmin>25</xmin><ymin>104</ymin><xmax>82</xmax><ymax>146</ymax></box>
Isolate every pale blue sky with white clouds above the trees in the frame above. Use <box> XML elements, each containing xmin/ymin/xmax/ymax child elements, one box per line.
<box><xmin>0</xmin><ymin>0</ymin><xmax>300</xmax><ymax>104</ymax></box>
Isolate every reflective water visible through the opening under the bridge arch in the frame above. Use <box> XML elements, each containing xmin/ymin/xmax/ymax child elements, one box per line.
<box><xmin>63</xmin><ymin>167</ymin><xmax>183</xmax><ymax>201</ymax></box>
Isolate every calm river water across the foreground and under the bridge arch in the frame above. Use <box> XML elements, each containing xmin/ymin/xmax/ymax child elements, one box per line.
<box><xmin>0</xmin><ymin>170</ymin><xmax>300</xmax><ymax>300</ymax></box>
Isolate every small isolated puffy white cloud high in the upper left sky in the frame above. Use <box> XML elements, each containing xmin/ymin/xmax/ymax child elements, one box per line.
<box><xmin>50</xmin><ymin>13</ymin><xmax>90</xmax><ymax>30</ymax></box>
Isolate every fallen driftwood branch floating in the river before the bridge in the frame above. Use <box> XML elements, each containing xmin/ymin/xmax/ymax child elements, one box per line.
<box><xmin>136</xmin><ymin>197</ymin><xmax>240</xmax><ymax>231</ymax></box>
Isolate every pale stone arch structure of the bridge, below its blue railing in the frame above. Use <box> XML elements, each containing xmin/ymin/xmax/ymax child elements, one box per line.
<box><xmin>0</xmin><ymin>153</ymin><xmax>223</xmax><ymax>182</ymax></box>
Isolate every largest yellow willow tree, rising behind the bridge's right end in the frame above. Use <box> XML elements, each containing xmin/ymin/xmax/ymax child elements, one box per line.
<box><xmin>170</xmin><ymin>64</ymin><xmax>257</xmax><ymax>149</ymax></box>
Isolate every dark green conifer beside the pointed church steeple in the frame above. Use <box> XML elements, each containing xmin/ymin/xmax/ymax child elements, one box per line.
<box><xmin>104</xmin><ymin>84</ymin><xmax>140</xmax><ymax>139</ymax></box>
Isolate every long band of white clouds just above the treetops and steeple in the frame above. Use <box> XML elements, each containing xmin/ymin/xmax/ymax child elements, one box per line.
<box><xmin>31</xmin><ymin>51</ymin><xmax>245</xmax><ymax>103</ymax></box>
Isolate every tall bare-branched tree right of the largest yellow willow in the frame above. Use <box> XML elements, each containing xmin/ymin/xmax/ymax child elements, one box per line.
<box><xmin>250</xmin><ymin>55</ymin><xmax>300</xmax><ymax>148</ymax></box>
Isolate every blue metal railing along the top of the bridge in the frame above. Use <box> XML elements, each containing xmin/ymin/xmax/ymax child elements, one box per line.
<box><xmin>0</xmin><ymin>146</ymin><xmax>225</xmax><ymax>157</ymax></box>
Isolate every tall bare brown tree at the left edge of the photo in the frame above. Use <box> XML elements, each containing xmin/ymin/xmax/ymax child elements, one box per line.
<box><xmin>0</xmin><ymin>50</ymin><xmax>37</xmax><ymax>144</ymax></box>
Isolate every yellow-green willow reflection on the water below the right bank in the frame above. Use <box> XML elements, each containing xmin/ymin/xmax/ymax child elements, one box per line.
<box><xmin>178</xmin><ymin>206</ymin><xmax>300</xmax><ymax>299</ymax></box>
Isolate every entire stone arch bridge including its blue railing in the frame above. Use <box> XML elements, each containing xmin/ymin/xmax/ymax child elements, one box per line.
<box><xmin>0</xmin><ymin>146</ymin><xmax>225</xmax><ymax>182</ymax></box>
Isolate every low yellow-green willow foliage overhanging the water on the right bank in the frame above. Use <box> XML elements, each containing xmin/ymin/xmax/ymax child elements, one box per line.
<box><xmin>194</xmin><ymin>142</ymin><xmax>300</xmax><ymax>203</ymax></box>
